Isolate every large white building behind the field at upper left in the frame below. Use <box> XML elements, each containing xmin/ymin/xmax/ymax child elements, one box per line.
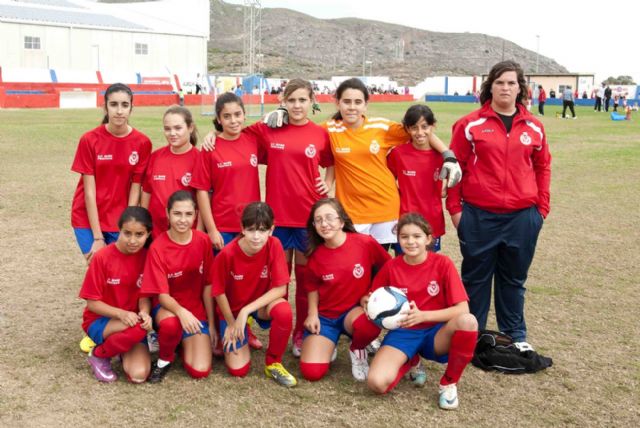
<box><xmin>0</xmin><ymin>0</ymin><xmax>210</xmax><ymax>76</ymax></box>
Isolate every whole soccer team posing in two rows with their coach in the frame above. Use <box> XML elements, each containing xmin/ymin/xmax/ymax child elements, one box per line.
<box><xmin>72</xmin><ymin>58</ymin><xmax>550</xmax><ymax>409</ymax></box>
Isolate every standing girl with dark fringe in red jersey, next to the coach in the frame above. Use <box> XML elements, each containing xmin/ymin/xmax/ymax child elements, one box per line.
<box><xmin>387</xmin><ymin>104</ymin><xmax>445</xmax><ymax>254</ymax></box>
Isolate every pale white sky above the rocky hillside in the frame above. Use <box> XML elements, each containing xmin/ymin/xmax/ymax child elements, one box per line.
<box><xmin>224</xmin><ymin>0</ymin><xmax>640</xmax><ymax>84</ymax></box>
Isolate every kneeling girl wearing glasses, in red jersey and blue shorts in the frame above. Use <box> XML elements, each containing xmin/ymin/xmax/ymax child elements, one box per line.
<box><xmin>300</xmin><ymin>198</ymin><xmax>391</xmax><ymax>381</ymax></box>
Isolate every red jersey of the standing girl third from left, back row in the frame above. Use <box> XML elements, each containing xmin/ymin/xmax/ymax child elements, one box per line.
<box><xmin>191</xmin><ymin>133</ymin><xmax>262</xmax><ymax>232</ymax></box>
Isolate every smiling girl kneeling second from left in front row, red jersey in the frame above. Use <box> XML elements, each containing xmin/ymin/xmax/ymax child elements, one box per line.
<box><xmin>142</xmin><ymin>190</ymin><xmax>217</xmax><ymax>383</ymax></box>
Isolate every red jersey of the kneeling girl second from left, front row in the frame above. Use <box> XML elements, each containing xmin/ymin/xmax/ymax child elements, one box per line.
<box><xmin>141</xmin><ymin>230</ymin><xmax>213</xmax><ymax>321</ymax></box>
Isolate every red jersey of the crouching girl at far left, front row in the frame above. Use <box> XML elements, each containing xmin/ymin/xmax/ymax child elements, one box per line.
<box><xmin>80</xmin><ymin>243</ymin><xmax>147</xmax><ymax>332</ymax></box>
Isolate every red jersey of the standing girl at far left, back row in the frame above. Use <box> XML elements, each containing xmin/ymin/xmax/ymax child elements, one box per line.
<box><xmin>71</xmin><ymin>125</ymin><xmax>151</xmax><ymax>232</ymax></box>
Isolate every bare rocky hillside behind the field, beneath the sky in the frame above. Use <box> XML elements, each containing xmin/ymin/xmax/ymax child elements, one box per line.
<box><xmin>209</xmin><ymin>0</ymin><xmax>567</xmax><ymax>85</ymax></box>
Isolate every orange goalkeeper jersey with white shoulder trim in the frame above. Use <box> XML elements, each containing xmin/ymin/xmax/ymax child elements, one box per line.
<box><xmin>323</xmin><ymin>117</ymin><xmax>409</xmax><ymax>224</ymax></box>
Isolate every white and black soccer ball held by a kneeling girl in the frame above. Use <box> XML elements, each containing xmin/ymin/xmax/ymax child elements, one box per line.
<box><xmin>367</xmin><ymin>286</ymin><xmax>409</xmax><ymax>330</ymax></box>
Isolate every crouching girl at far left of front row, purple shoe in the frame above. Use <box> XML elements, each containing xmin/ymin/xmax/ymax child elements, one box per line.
<box><xmin>80</xmin><ymin>207</ymin><xmax>152</xmax><ymax>383</ymax></box>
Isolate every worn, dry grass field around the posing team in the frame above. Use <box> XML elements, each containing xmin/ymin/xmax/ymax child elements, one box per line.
<box><xmin>0</xmin><ymin>103</ymin><xmax>640</xmax><ymax>427</ymax></box>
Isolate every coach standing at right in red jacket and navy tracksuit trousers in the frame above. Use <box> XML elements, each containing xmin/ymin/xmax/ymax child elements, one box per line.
<box><xmin>447</xmin><ymin>61</ymin><xmax>551</xmax><ymax>350</ymax></box>
